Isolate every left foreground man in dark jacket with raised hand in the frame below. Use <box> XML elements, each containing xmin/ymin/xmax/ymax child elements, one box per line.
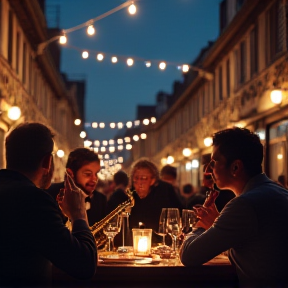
<box><xmin>0</xmin><ymin>123</ymin><xmax>97</xmax><ymax>287</ymax></box>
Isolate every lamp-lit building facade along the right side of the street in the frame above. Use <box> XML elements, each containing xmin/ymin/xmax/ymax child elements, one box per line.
<box><xmin>132</xmin><ymin>0</ymin><xmax>288</xmax><ymax>187</ymax></box>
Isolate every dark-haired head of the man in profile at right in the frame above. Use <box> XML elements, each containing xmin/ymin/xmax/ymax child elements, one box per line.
<box><xmin>208</xmin><ymin>127</ymin><xmax>263</xmax><ymax>189</ymax></box>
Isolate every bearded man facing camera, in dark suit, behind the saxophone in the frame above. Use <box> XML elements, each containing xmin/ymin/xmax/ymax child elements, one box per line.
<box><xmin>48</xmin><ymin>148</ymin><xmax>107</xmax><ymax>226</ymax></box>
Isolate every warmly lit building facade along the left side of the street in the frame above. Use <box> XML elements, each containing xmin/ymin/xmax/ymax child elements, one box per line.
<box><xmin>0</xmin><ymin>0</ymin><xmax>84</xmax><ymax>181</ymax></box>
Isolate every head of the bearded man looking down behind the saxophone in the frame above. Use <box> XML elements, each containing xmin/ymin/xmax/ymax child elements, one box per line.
<box><xmin>66</xmin><ymin>148</ymin><xmax>100</xmax><ymax>195</ymax></box>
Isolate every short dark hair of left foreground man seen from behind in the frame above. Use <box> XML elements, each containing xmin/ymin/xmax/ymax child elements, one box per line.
<box><xmin>5</xmin><ymin>122</ymin><xmax>54</xmax><ymax>172</ymax></box>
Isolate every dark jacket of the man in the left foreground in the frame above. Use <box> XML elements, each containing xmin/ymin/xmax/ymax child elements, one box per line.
<box><xmin>0</xmin><ymin>169</ymin><xmax>97</xmax><ymax>287</ymax></box>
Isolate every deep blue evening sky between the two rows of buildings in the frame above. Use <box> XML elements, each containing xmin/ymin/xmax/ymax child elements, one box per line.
<box><xmin>47</xmin><ymin>0</ymin><xmax>221</xmax><ymax>140</ymax></box>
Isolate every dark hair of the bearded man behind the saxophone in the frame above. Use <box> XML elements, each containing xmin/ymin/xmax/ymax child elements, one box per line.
<box><xmin>66</xmin><ymin>148</ymin><xmax>100</xmax><ymax>174</ymax></box>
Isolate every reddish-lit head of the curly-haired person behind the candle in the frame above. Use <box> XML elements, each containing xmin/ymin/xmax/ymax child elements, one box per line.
<box><xmin>131</xmin><ymin>159</ymin><xmax>159</xmax><ymax>198</ymax></box>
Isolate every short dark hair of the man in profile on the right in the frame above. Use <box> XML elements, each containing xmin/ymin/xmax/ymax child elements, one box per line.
<box><xmin>213</xmin><ymin>127</ymin><xmax>263</xmax><ymax>177</ymax></box>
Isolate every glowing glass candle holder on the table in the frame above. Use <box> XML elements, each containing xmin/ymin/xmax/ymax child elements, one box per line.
<box><xmin>132</xmin><ymin>229</ymin><xmax>152</xmax><ymax>256</ymax></box>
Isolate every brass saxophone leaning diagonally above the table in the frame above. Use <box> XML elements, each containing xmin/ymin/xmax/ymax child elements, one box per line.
<box><xmin>90</xmin><ymin>189</ymin><xmax>135</xmax><ymax>248</ymax></box>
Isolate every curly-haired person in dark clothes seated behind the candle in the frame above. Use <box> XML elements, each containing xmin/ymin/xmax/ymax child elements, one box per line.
<box><xmin>106</xmin><ymin>159</ymin><xmax>181</xmax><ymax>245</ymax></box>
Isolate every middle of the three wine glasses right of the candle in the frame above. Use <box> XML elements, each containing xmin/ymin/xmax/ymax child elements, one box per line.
<box><xmin>167</xmin><ymin>208</ymin><xmax>181</xmax><ymax>251</ymax></box>
